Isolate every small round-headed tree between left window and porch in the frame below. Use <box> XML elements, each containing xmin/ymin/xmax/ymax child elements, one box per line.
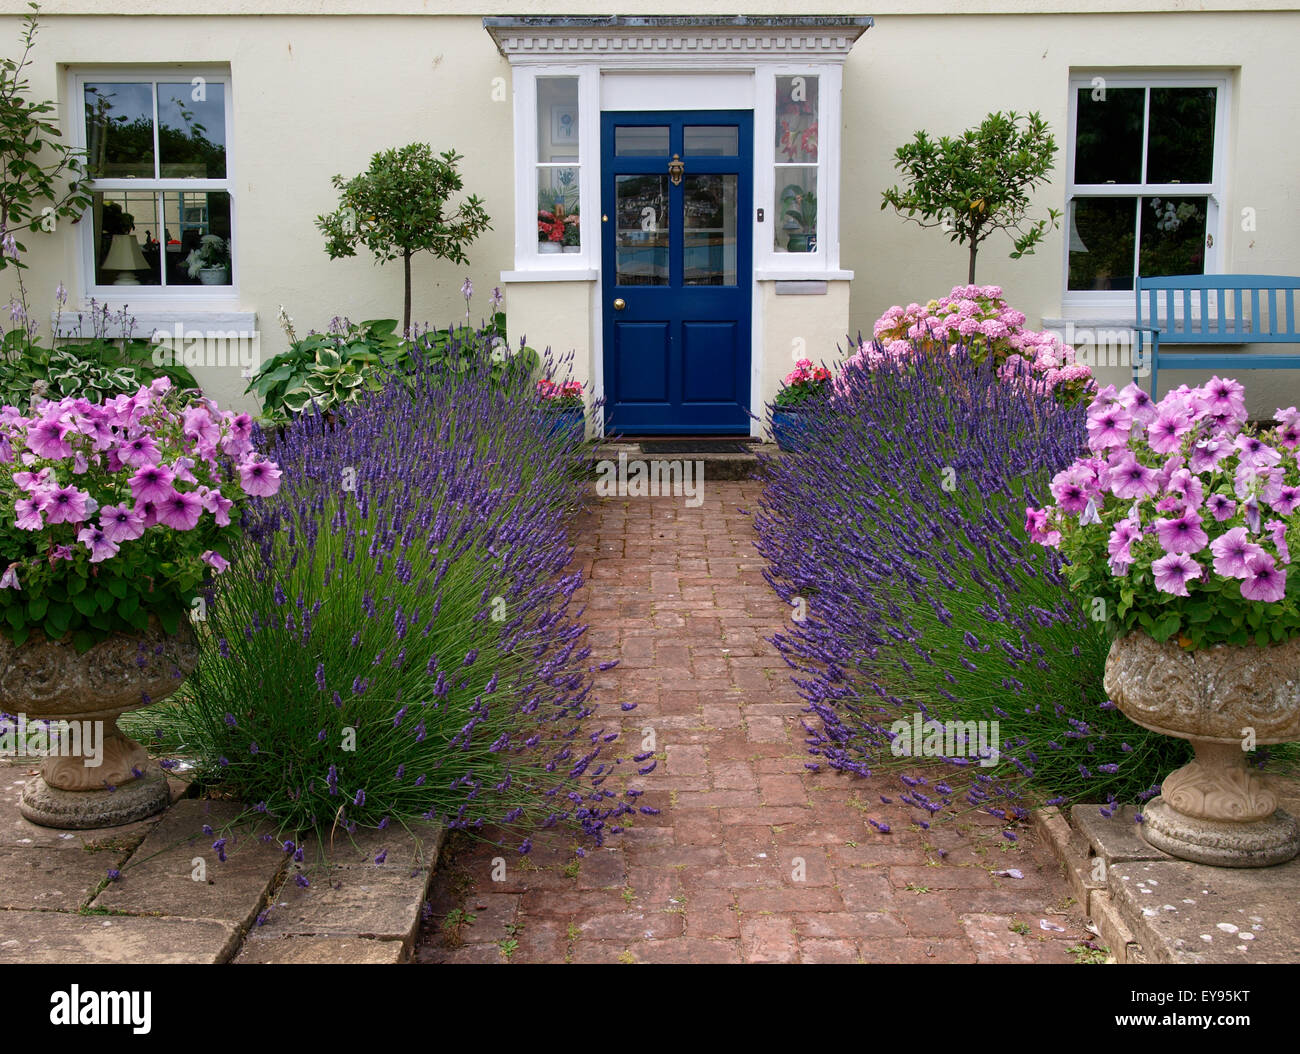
<box><xmin>316</xmin><ymin>143</ymin><xmax>491</xmax><ymax>333</ymax></box>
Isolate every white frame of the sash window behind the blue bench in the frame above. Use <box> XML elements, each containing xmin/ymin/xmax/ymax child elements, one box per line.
<box><xmin>1061</xmin><ymin>70</ymin><xmax>1231</xmax><ymax>318</ymax></box>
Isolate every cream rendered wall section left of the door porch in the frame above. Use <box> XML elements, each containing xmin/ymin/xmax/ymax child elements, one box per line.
<box><xmin>0</xmin><ymin>14</ymin><xmax>514</xmax><ymax>408</ymax></box>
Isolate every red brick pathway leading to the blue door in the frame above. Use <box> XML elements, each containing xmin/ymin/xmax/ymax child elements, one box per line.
<box><xmin>419</xmin><ymin>482</ymin><xmax>1089</xmax><ymax>962</ymax></box>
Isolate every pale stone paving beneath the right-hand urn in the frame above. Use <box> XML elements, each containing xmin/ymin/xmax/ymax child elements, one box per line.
<box><xmin>1034</xmin><ymin>784</ymin><xmax>1300</xmax><ymax>963</ymax></box>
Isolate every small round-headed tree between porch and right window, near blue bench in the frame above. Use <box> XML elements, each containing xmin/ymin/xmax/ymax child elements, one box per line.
<box><xmin>880</xmin><ymin>110</ymin><xmax>1061</xmax><ymax>285</ymax></box>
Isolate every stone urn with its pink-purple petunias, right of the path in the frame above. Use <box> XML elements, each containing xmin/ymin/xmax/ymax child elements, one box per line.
<box><xmin>1026</xmin><ymin>377</ymin><xmax>1300</xmax><ymax>867</ymax></box>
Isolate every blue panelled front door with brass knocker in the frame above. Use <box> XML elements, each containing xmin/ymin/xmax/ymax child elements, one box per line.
<box><xmin>601</xmin><ymin>110</ymin><xmax>754</xmax><ymax>435</ymax></box>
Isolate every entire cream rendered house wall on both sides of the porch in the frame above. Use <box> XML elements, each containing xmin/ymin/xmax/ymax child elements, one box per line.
<box><xmin>0</xmin><ymin>0</ymin><xmax>1300</xmax><ymax>423</ymax></box>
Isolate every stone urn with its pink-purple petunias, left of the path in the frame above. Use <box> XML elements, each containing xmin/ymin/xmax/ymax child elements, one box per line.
<box><xmin>0</xmin><ymin>378</ymin><xmax>280</xmax><ymax>828</ymax></box>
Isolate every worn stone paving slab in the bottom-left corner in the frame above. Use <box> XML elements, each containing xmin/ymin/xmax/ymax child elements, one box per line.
<box><xmin>0</xmin><ymin>911</ymin><xmax>239</xmax><ymax>966</ymax></box>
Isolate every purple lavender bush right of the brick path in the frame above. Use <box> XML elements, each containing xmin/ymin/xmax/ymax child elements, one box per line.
<box><xmin>755</xmin><ymin>348</ymin><xmax>1190</xmax><ymax>824</ymax></box>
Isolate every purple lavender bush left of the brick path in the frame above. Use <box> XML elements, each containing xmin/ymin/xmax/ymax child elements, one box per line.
<box><xmin>137</xmin><ymin>332</ymin><xmax>640</xmax><ymax>853</ymax></box>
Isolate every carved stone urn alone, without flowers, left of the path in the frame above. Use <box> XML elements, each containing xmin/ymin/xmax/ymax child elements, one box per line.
<box><xmin>0</xmin><ymin>619</ymin><xmax>199</xmax><ymax>829</ymax></box>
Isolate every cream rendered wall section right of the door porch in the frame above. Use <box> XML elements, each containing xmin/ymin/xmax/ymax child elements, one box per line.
<box><xmin>841</xmin><ymin>13</ymin><xmax>1300</xmax><ymax>413</ymax></box>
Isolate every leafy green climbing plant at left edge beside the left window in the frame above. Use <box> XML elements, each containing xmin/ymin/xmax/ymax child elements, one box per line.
<box><xmin>0</xmin><ymin>4</ymin><xmax>91</xmax><ymax>270</ymax></box>
